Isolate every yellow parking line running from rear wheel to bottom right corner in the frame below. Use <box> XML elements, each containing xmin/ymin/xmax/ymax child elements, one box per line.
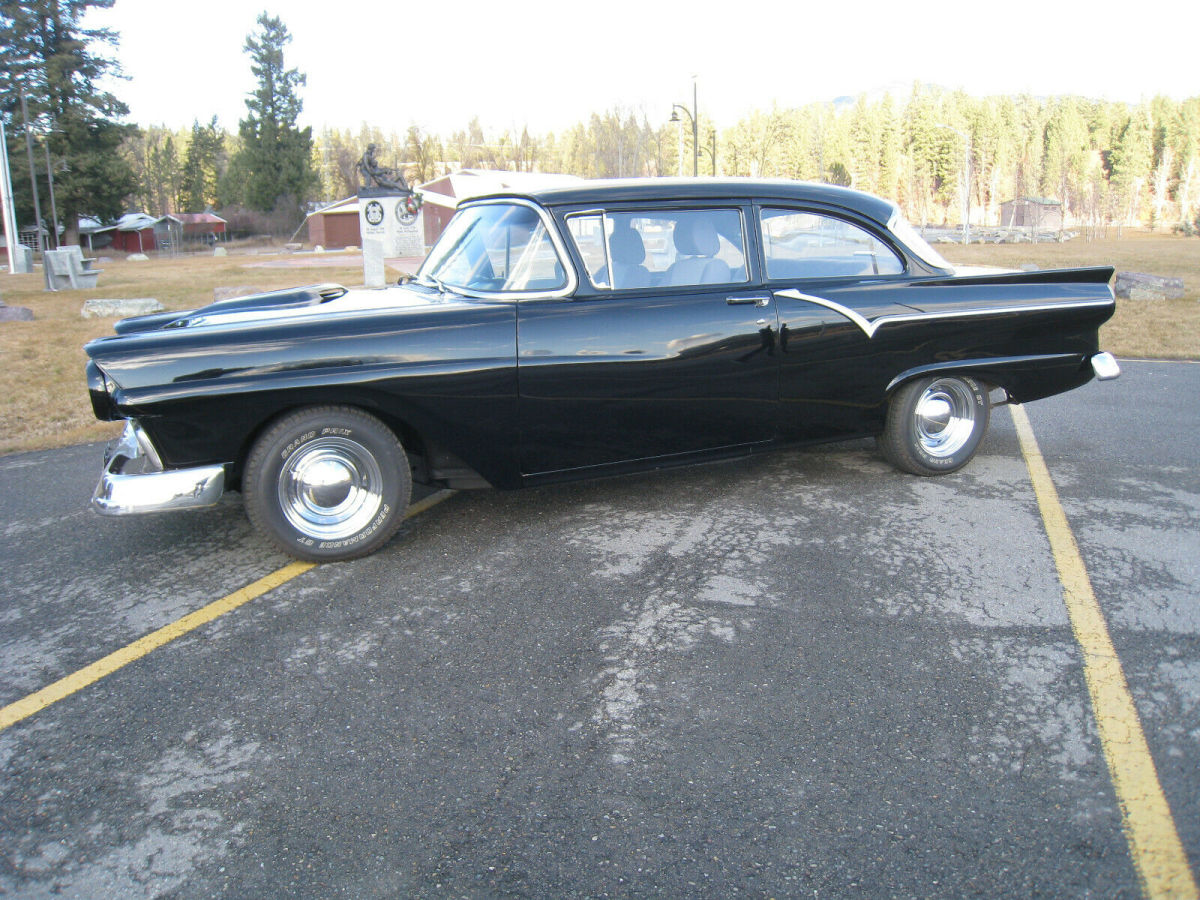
<box><xmin>1009</xmin><ymin>404</ymin><xmax>1200</xmax><ymax>900</ymax></box>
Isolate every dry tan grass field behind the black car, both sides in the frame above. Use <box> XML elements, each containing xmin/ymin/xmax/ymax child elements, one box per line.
<box><xmin>0</xmin><ymin>232</ymin><xmax>1200</xmax><ymax>454</ymax></box>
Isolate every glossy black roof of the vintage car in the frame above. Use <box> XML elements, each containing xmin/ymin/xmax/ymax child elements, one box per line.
<box><xmin>466</xmin><ymin>178</ymin><xmax>896</xmax><ymax>226</ymax></box>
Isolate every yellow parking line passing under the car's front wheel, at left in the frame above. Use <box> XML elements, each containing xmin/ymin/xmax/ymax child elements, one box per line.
<box><xmin>0</xmin><ymin>491</ymin><xmax>454</xmax><ymax>731</ymax></box>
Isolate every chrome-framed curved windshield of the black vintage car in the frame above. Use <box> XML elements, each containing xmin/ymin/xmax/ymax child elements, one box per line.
<box><xmin>418</xmin><ymin>203</ymin><xmax>566</xmax><ymax>294</ymax></box>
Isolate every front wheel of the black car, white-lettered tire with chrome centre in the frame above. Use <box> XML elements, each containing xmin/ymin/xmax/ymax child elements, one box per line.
<box><xmin>242</xmin><ymin>407</ymin><xmax>413</xmax><ymax>562</ymax></box>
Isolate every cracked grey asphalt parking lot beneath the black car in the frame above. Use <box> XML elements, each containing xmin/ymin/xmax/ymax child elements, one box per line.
<box><xmin>0</xmin><ymin>362</ymin><xmax>1200</xmax><ymax>898</ymax></box>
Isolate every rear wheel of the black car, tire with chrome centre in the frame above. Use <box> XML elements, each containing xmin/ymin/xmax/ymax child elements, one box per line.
<box><xmin>880</xmin><ymin>376</ymin><xmax>991</xmax><ymax>475</ymax></box>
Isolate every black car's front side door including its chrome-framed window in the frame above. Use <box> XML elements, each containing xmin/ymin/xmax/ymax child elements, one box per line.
<box><xmin>517</xmin><ymin>206</ymin><xmax>779</xmax><ymax>476</ymax></box>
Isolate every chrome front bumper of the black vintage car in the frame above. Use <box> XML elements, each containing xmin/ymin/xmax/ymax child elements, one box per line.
<box><xmin>91</xmin><ymin>419</ymin><xmax>224</xmax><ymax>516</ymax></box>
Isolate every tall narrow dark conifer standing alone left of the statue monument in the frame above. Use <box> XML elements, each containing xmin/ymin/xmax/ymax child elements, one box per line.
<box><xmin>230</xmin><ymin>12</ymin><xmax>318</xmax><ymax>219</ymax></box>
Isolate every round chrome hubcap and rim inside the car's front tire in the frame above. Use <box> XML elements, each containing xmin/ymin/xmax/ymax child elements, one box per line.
<box><xmin>278</xmin><ymin>437</ymin><xmax>383</xmax><ymax>540</ymax></box>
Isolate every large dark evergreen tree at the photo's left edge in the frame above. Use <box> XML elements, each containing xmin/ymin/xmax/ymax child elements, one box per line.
<box><xmin>0</xmin><ymin>0</ymin><xmax>137</xmax><ymax>241</ymax></box>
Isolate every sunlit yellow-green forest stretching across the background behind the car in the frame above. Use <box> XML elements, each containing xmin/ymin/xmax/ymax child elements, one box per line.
<box><xmin>125</xmin><ymin>86</ymin><xmax>1200</xmax><ymax>233</ymax></box>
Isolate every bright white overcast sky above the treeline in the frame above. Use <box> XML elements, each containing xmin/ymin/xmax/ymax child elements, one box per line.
<box><xmin>88</xmin><ymin>0</ymin><xmax>1200</xmax><ymax>134</ymax></box>
